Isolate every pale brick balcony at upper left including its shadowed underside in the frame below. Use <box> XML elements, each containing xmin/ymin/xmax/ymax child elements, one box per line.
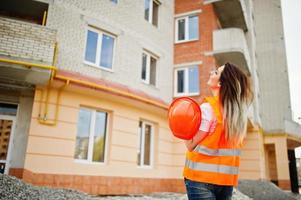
<box><xmin>0</xmin><ymin>17</ymin><xmax>56</xmax><ymax>87</ymax></box>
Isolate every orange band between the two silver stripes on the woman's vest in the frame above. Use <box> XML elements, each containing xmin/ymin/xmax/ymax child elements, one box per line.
<box><xmin>186</xmin><ymin>152</ymin><xmax>240</xmax><ymax>167</ymax></box>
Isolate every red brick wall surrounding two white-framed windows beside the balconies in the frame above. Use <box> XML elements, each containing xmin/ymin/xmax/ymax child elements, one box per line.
<box><xmin>174</xmin><ymin>0</ymin><xmax>218</xmax><ymax>100</ymax></box>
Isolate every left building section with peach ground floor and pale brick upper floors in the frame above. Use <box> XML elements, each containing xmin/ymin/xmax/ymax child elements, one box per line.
<box><xmin>0</xmin><ymin>0</ymin><xmax>184</xmax><ymax>194</ymax></box>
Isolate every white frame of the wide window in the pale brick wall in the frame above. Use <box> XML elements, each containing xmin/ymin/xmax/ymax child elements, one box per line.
<box><xmin>83</xmin><ymin>26</ymin><xmax>117</xmax><ymax>72</ymax></box>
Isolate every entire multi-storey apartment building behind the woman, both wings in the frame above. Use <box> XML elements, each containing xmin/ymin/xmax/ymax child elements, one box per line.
<box><xmin>0</xmin><ymin>0</ymin><xmax>301</xmax><ymax>194</ymax></box>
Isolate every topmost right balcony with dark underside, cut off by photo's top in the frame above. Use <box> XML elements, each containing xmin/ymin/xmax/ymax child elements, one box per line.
<box><xmin>204</xmin><ymin>0</ymin><xmax>248</xmax><ymax>31</ymax></box>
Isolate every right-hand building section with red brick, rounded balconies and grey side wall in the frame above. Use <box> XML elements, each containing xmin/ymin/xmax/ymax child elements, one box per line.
<box><xmin>174</xmin><ymin>0</ymin><xmax>301</xmax><ymax>192</ymax></box>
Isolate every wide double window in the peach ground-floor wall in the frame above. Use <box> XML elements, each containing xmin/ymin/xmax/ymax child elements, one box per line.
<box><xmin>74</xmin><ymin>108</ymin><xmax>108</xmax><ymax>163</ymax></box>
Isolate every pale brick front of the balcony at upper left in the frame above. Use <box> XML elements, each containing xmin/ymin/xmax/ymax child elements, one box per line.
<box><xmin>0</xmin><ymin>17</ymin><xmax>56</xmax><ymax>64</ymax></box>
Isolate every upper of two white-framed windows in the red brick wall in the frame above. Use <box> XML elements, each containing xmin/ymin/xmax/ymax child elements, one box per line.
<box><xmin>175</xmin><ymin>15</ymin><xmax>199</xmax><ymax>42</ymax></box>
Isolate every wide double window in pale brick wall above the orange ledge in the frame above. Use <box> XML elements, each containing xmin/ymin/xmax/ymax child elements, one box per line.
<box><xmin>85</xmin><ymin>27</ymin><xmax>115</xmax><ymax>70</ymax></box>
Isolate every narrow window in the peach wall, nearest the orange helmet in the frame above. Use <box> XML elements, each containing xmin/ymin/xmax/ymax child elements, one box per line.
<box><xmin>137</xmin><ymin>121</ymin><xmax>154</xmax><ymax>167</ymax></box>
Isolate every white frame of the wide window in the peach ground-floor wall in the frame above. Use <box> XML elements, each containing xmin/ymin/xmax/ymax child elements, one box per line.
<box><xmin>74</xmin><ymin>107</ymin><xmax>109</xmax><ymax>165</ymax></box>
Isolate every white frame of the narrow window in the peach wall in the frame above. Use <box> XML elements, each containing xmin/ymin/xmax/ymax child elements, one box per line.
<box><xmin>137</xmin><ymin>120</ymin><xmax>155</xmax><ymax>169</ymax></box>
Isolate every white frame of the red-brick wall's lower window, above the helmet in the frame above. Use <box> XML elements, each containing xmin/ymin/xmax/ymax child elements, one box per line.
<box><xmin>174</xmin><ymin>65</ymin><xmax>200</xmax><ymax>97</ymax></box>
